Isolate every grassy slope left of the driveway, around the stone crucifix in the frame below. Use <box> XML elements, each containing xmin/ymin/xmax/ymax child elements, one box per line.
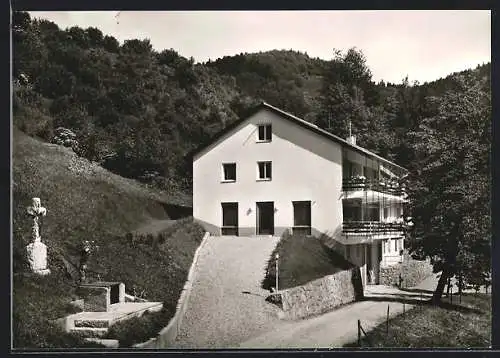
<box><xmin>13</xmin><ymin>130</ymin><xmax>202</xmax><ymax>347</ymax></box>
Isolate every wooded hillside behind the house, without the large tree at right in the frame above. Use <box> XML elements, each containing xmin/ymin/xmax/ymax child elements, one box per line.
<box><xmin>13</xmin><ymin>12</ymin><xmax>490</xmax><ymax>185</ymax></box>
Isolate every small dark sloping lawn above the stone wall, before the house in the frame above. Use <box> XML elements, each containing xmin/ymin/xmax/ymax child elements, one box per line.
<box><xmin>262</xmin><ymin>233</ymin><xmax>352</xmax><ymax>289</ymax></box>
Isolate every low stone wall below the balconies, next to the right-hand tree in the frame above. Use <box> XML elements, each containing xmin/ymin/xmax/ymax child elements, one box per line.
<box><xmin>380</xmin><ymin>254</ymin><xmax>432</xmax><ymax>287</ymax></box>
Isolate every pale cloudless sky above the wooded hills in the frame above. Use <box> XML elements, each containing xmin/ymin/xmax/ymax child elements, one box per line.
<box><xmin>30</xmin><ymin>10</ymin><xmax>491</xmax><ymax>83</ymax></box>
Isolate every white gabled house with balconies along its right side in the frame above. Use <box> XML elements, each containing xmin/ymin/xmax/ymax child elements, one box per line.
<box><xmin>193</xmin><ymin>103</ymin><xmax>407</xmax><ymax>284</ymax></box>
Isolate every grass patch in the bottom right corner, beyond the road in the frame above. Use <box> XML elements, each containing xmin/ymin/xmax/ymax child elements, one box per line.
<box><xmin>345</xmin><ymin>293</ymin><xmax>491</xmax><ymax>348</ymax></box>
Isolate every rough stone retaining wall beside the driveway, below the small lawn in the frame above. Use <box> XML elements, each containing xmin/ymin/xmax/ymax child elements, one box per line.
<box><xmin>280</xmin><ymin>267</ymin><xmax>363</xmax><ymax>319</ymax></box>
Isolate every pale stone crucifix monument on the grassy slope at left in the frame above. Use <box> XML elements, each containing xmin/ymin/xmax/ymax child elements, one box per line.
<box><xmin>26</xmin><ymin>198</ymin><xmax>50</xmax><ymax>275</ymax></box>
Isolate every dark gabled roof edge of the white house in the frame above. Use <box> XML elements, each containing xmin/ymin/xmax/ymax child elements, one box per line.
<box><xmin>191</xmin><ymin>102</ymin><xmax>408</xmax><ymax>172</ymax></box>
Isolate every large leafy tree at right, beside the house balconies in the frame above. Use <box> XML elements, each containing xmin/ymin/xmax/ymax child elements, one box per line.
<box><xmin>407</xmin><ymin>74</ymin><xmax>491</xmax><ymax>303</ymax></box>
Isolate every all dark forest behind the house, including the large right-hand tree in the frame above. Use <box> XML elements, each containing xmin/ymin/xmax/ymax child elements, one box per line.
<box><xmin>12</xmin><ymin>12</ymin><xmax>491</xmax><ymax>296</ymax></box>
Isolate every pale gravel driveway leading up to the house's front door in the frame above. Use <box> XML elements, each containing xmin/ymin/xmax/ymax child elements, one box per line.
<box><xmin>169</xmin><ymin>237</ymin><xmax>279</xmax><ymax>349</ymax></box>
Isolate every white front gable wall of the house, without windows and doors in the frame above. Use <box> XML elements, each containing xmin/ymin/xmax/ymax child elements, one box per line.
<box><xmin>193</xmin><ymin>109</ymin><xmax>342</xmax><ymax>236</ymax></box>
